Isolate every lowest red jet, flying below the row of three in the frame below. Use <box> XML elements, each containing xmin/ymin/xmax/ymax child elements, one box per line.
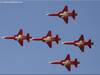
<box><xmin>49</xmin><ymin>54</ymin><xmax>80</xmax><ymax>71</ymax></box>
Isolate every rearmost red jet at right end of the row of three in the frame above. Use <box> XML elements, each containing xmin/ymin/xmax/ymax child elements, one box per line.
<box><xmin>63</xmin><ymin>35</ymin><xmax>94</xmax><ymax>52</ymax></box>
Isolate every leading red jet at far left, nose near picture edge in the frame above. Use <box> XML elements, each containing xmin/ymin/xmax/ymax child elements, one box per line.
<box><xmin>2</xmin><ymin>29</ymin><xmax>32</xmax><ymax>46</ymax></box>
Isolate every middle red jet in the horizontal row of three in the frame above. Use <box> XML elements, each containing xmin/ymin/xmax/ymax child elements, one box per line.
<box><xmin>32</xmin><ymin>31</ymin><xmax>61</xmax><ymax>48</ymax></box>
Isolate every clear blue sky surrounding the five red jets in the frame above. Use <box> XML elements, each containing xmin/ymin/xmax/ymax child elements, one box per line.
<box><xmin>0</xmin><ymin>0</ymin><xmax>100</xmax><ymax>74</ymax></box>
